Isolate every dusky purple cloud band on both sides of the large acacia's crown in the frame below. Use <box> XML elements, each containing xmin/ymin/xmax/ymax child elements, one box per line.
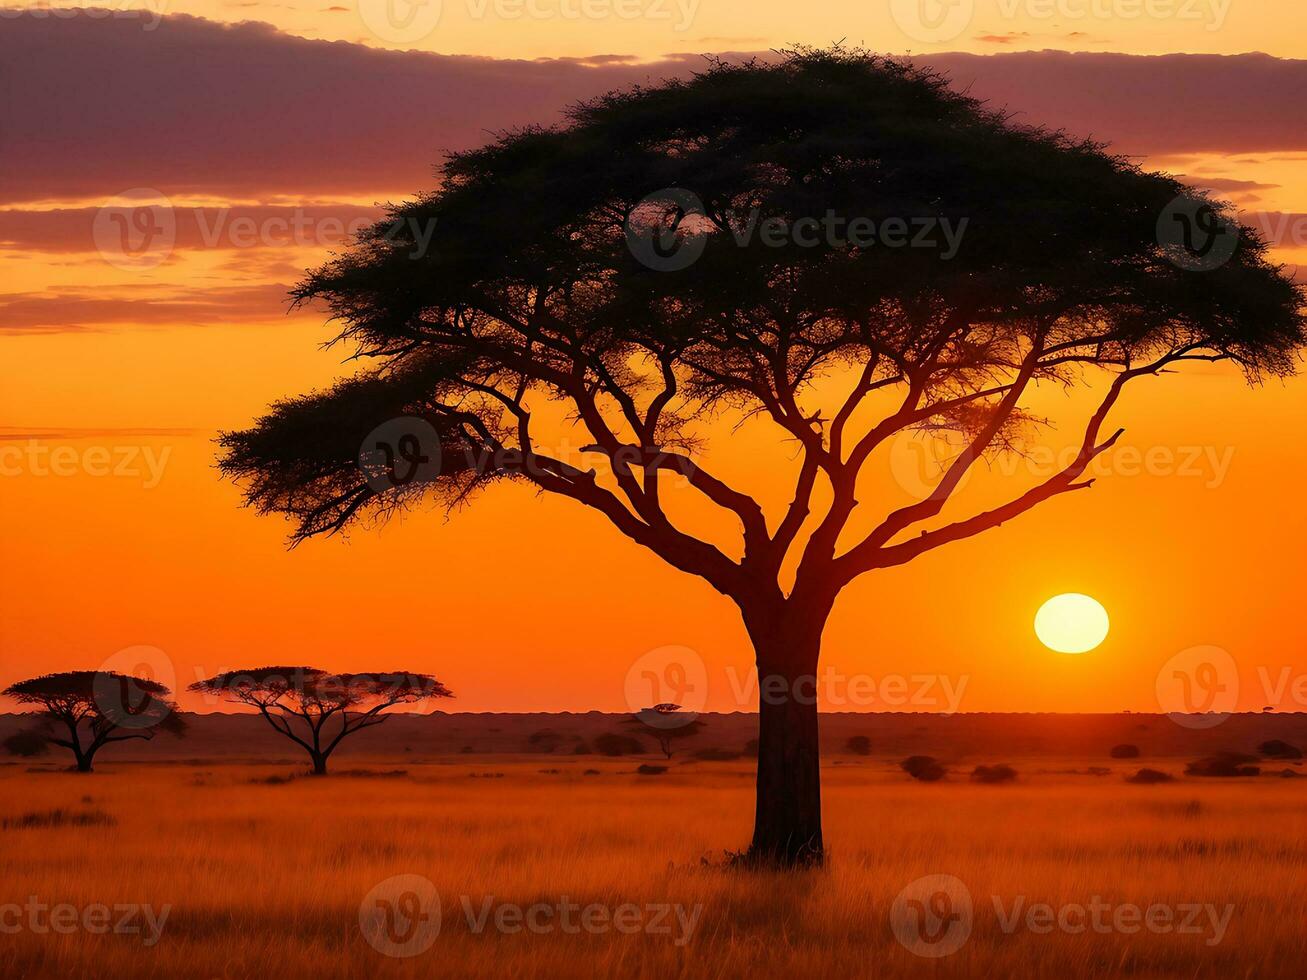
<box><xmin>0</xmin><ymin>14</ymin><xmax>1307</xmax><ymax>203</ymax></box>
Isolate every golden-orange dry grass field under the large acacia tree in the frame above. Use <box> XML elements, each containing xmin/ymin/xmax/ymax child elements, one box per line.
<box><xmin>0</xmin><ymin>757</ymin><xmax>1307</xmax><ymax>980</ymax></box>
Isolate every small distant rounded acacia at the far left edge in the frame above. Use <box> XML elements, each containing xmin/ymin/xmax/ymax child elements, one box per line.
<box><xmin>0</xmin><ymin>670</ymin><xmax>186</xmax><ymax>772</ymax></box>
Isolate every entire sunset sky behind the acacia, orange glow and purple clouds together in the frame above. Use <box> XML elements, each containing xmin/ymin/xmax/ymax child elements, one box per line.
<box><xmin>0</xmin><ymin>0</ymin><xmax>1307</xmax><ymax>711</ymax></box>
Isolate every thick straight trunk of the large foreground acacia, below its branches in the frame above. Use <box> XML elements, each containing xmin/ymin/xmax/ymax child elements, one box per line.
<box><xmin>748</xmin><ymin>619</ymin><xmax>825</xmax><ymax>868</ymax></box>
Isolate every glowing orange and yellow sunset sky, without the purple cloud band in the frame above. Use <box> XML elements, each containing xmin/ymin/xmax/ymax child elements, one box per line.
<box><xmin>0</xmin><ymin>0</ymin><xmax>1307</xmax><ymax>711</ymax></box>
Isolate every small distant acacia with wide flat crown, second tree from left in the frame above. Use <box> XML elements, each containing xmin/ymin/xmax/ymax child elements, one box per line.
<box><xmin>190</xmin><ymin>666</ymin><xmax>454</xmax><ymax>776</ymax></box>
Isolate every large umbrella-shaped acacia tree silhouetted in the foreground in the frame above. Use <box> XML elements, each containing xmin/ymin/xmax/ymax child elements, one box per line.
<box><xmin>222</xmin><ymin>50</ymin><xmax>1304</xmax><ymax>864</ymax></box>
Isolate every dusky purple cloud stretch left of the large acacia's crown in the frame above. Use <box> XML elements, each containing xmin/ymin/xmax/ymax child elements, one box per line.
<box><xmin>0</xmin><ymin>14</ymin><xmax>702</xmax><ymax>203</ymax></box>
